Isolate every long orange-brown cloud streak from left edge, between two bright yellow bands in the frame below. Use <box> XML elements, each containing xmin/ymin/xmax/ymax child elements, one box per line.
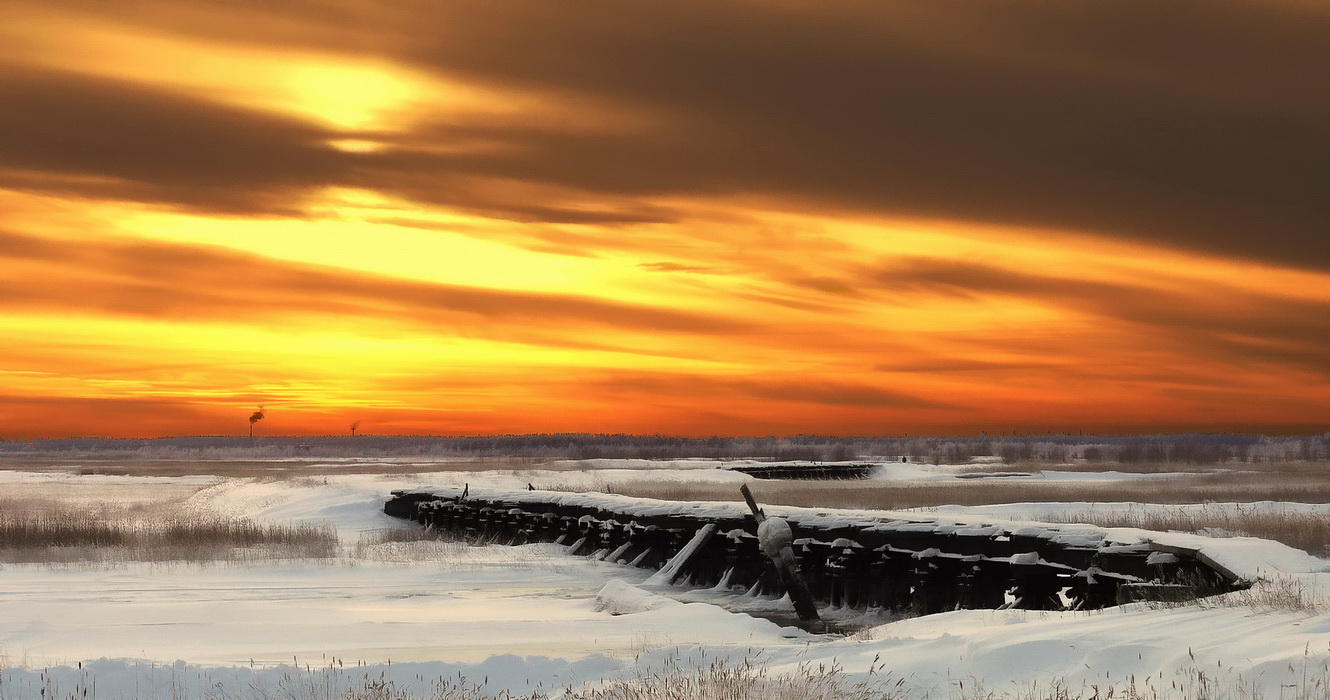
<box><xmin>0</xmin><ymin>232</ymin><xmax>753</xmax><ymax>335</ymax></box>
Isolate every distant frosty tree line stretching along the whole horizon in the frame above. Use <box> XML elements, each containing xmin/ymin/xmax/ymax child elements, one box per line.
<box><xmin>0</xmin><ymin>433</ymin><xmax>1330</xmax><ymax>464</ymax></box>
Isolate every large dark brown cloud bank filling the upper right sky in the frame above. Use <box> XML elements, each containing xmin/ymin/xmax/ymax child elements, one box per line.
<box><xmin>385</xmin><ymin>0</ymin><xmax>1330</xmax><ymax>267</ymax></box>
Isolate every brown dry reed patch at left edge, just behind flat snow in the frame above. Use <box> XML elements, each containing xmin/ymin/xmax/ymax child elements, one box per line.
<box><xmin>0</xmin><ymin>506</ymin><xmax>339</xmax><ymax>564</ymax></box>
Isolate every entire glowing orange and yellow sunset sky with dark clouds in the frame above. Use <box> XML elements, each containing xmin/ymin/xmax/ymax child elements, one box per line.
<box><xmin>0</xmin><ymin>0</ymin><xmax>1330</xmax><ymax>439</ymax></box>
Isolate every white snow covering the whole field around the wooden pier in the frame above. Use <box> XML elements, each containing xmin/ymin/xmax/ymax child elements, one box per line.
<box><xmin>0</xmin><ymin>460</ymin><xmax>1330</xmax><ymax>699</ymax></box>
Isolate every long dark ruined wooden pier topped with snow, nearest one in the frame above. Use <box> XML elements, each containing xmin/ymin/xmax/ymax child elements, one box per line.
<box><xmin>383</xmin><ymin>490</ymin><xmax>1249</xmax><ymax>615</ymax></box>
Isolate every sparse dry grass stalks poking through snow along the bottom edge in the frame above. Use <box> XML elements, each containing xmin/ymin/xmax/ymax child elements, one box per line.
<box><xmin>18</xmin><ymin>647</ymin><xmax>1330</xmax><ymax>700</ymax></box>
